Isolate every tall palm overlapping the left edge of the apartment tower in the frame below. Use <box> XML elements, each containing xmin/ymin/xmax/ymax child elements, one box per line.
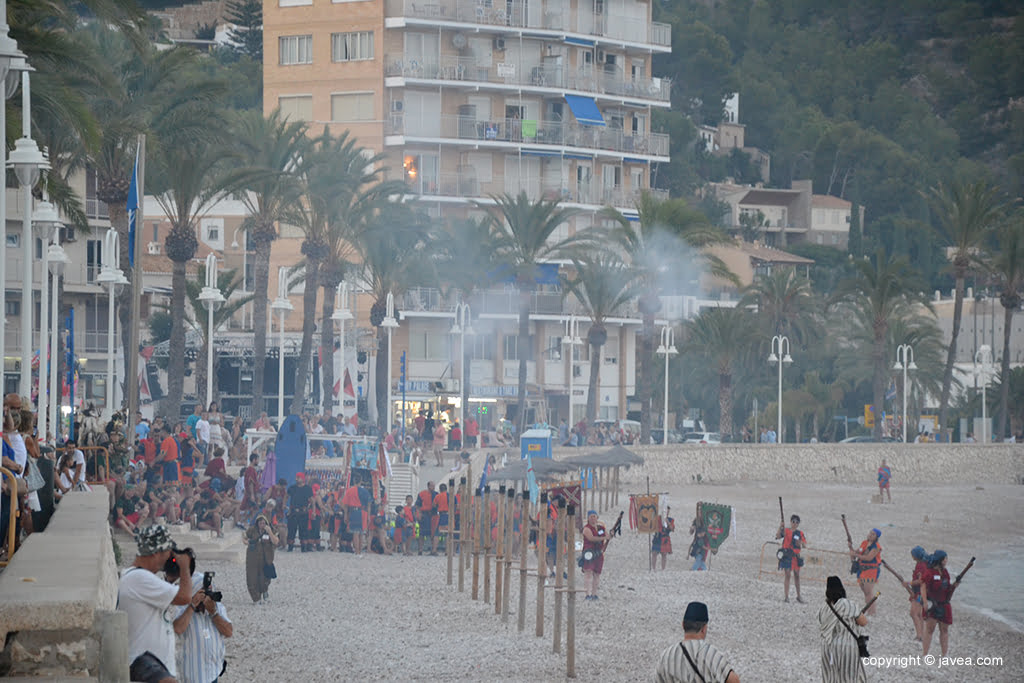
<box><xmin>234</xmin><ymin>110</ymin><xmax>309</xmax><ymax>413</ymax></box>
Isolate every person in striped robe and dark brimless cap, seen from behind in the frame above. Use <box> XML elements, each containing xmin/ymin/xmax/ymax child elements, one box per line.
<box><xmin>654</xmin><ymin>602</ymin><xmax>739</xmax><ymax>683</ymax></box>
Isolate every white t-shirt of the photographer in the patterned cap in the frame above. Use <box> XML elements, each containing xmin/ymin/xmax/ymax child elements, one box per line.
<box><xmin>118</xmin><ymin>567</ymin><xmax>178</xmax><ymax>676</ymax></box>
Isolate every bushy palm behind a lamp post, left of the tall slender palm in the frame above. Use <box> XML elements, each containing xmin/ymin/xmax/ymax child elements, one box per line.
<box><xmin>836</xmin><ymin>249</ymin><xmax>930</xmax><ymax>439</ymax></box>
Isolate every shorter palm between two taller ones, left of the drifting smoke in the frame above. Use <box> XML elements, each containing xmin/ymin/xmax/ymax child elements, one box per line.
<box><xmin>562</xmin><ymin>252</ymin><xmax>638</xmax><ymax>429</ymax></box>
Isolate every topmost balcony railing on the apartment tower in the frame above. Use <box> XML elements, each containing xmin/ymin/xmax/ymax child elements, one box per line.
<box><xmin>385</xmin><ymin>0</ymin><xmax>672</xmax><ymax>47</ymax></box>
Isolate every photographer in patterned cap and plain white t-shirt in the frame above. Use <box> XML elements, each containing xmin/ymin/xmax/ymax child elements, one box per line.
<box><xmin>117</xmin><ymin>524</ymin><xmax>193</xmax><ymax>683</ymax></box>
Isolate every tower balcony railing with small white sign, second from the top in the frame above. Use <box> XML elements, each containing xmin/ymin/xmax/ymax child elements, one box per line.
<box><xmin>384</xmin><ymin>55</ymin><xmax>672</xmax><ymax>102</ymax></box>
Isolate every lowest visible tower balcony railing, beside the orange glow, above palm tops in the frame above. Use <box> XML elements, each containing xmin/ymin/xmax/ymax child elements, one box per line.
<box><xmin>409</xmin><ymin>167</ymin><xmax>669</xmax><ymax>209</ymax></box>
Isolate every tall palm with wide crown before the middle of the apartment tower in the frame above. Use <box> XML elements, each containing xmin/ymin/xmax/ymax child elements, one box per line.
<box><xmin>477</xmin><ymin>191</ymin><xmax>579</xmax><ymax>434</ymax></box>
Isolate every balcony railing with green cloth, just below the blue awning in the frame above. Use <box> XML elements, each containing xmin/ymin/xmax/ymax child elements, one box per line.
<box><xmin>387</xmin><ymin>112</ymin><xmax>669</xmax><ymax>157</ymax></box>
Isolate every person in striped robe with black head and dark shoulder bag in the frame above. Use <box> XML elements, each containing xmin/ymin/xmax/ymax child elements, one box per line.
<box><xmin>818</xmin><ymin>577</ymin><xmax>867</xmax><ymax>683</ymax></box>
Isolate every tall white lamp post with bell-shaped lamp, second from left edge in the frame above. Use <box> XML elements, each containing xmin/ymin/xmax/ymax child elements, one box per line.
<box><xmin>5</xmin><ymin>71</ymin><xmax>50</xmax><ymax>396</ymax></box>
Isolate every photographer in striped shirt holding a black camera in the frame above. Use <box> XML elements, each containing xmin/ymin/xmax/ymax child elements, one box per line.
<box><xmin>173</xmin><ymin>560</ymin><xmax>233</xmax><ymax>683</ymax></box>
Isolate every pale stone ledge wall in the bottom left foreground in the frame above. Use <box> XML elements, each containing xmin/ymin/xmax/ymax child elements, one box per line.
<box><xmin>0</xmin><ymin>487</ymin><xmax>128</xmax><ymax>681</ymax></box>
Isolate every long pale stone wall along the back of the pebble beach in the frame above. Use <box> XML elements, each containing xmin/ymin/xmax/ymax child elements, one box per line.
<box><xmin>555</xmin><ymin>443</ymin><xmax>1024</xmax><ymax>485</ymax></box>
